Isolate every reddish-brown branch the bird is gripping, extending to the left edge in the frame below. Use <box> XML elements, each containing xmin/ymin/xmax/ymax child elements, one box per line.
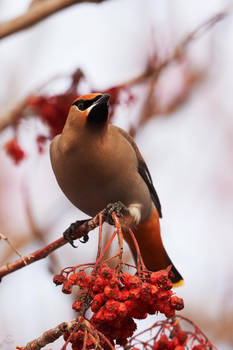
<box><xmin>0</xmin><ymin>211</ymin><xmax>107</xmax><ymax>281</ymax></box>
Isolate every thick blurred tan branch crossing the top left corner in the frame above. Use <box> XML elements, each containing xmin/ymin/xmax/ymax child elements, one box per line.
<box><xmin>0</xmin><ymin>0</ymin><xmax>104</xmax><ymax>39</ymax></box>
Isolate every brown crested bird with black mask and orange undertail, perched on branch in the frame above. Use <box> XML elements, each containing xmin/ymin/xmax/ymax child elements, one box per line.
<box><xmin>50</xmin><ymin>93</ymin><xmax>183</xmax><ymax>286</ymax></box>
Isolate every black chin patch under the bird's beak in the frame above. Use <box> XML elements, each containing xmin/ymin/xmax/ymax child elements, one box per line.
<box><xmin>87</xmin><ymin>94</ymin><xmax>110</xmax><ymax>125</ymax></box>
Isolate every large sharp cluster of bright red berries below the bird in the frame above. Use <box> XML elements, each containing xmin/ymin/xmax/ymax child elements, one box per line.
<box><xmin>54</xmin><ymin>264</ymin><xmax>184</xmax><ymax>350</ymax></box>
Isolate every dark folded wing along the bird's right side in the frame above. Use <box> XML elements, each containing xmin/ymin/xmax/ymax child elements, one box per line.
<box><xmin>116</xmin><ymin>127</ymin><xmax>162</xmax><ymax>218</ymax></box>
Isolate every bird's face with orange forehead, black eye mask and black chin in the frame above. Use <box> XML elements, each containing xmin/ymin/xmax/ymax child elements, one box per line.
<box><xmin>71</xmin><ymin>93</ymin><xmax>110</xmax><ymax>127</ymax></box>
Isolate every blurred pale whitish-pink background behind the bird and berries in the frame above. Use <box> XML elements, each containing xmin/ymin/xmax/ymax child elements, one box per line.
<box><xmin>0</xmin><ymin>0</ymin><xmax>233</xmax><ymax>350</ymax></box>
